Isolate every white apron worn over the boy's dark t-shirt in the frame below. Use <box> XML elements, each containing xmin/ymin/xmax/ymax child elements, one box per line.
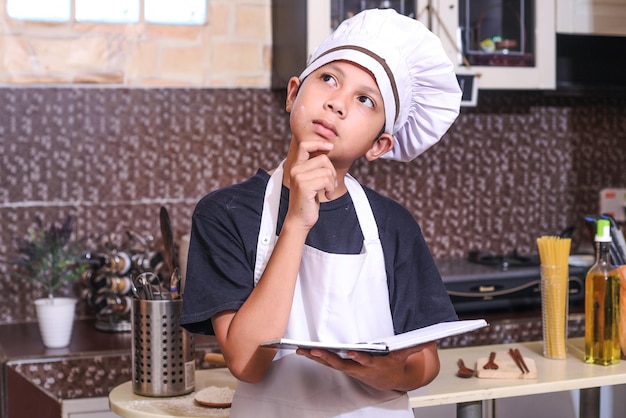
<box><xmin>230</xmin><ymin>163</ymin><xmax>413</xmax><ymax>418</ymax></box>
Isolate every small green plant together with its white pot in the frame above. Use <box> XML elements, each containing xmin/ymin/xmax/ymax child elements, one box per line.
<box><xmin>14</xmin><ymin>216</ymin><xmax>88</xmax><ymax>348</ymax></box>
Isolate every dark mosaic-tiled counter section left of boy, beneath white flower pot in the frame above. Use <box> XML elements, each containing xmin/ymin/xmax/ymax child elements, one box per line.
<box><xmin>0</xmin><ymin>320</ymin><xmax>217</xmax><ymax>418</ymax></box>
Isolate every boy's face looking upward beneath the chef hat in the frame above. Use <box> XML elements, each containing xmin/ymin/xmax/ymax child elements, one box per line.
<box><xmin>287</xmin><ymin>61</ymin><xmax>393</xmax><ymax>167</ymax></box>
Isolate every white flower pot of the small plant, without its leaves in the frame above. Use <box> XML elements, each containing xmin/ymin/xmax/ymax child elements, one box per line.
<box><xmin>35</xmin><ymin>298</ymin><xmax>77</xmax><ymax>348</ymax></box>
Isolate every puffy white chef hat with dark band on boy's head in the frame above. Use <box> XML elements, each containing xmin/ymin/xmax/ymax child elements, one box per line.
<box><xmin>300</xmin><ymin>9</ymin><xmax>461</xmax><ymax>161</ymax></box>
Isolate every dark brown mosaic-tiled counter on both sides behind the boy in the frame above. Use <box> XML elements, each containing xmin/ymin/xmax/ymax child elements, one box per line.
<box><xmin>0</xmin><ymin>308</ymin><xmax>584</xmax><ymax>418</ymax></box>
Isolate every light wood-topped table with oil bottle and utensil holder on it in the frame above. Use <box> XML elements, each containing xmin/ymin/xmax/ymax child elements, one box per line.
<box><xmin>109</xmin><ymin>338</ymin><xmax>626</xmax><ymax>418</ymax></box>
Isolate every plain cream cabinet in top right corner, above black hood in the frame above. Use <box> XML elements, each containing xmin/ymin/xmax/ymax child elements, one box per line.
<box><xmin>556</xmin><ymin>0</ymin><xmax>626</xmax><ymax>35</ymax></box>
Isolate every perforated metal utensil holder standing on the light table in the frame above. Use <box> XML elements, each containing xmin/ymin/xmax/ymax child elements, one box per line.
<box><xmin>131</xmin><ymin>299</ymin><xmax>196</xmax><ymax>397</ymax></box>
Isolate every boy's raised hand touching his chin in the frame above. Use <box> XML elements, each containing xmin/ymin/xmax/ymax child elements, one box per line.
<box><xmin>288</xmin><ymin>139</ymin><xmax>337</xmax><ymax>229</ymax></box>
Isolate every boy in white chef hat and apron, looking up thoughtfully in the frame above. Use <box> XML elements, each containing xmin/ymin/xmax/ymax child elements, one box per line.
<box><xmin>181</xmin><ymin>10</ymin><xmax>461</xmax><ymax>418</ymax></box>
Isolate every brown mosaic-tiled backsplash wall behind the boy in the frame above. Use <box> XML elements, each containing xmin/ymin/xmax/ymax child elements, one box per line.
<box><xmin>0</xmin><ymin>87</ymin><xmax>626</xmax><ymax>323</ymax></box>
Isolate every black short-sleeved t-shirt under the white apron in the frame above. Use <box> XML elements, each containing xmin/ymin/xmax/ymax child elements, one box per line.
<box><xmin>180</xmin><ymin>170</ymin><xmax>457</xmax><ymax>335</ymax></box>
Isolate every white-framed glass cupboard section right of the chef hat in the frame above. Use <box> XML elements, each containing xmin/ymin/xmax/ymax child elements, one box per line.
<box><xmin>418</xmin><ymin>0</ymin><xmax>556</xmax><ymax>90</ymax></box>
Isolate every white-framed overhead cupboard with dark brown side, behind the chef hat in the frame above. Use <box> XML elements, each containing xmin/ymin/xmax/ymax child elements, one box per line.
<box><xmin>272</xmin><ymin>0</ymin><xmax>556</xmax><ymax>89</ymax></box>
